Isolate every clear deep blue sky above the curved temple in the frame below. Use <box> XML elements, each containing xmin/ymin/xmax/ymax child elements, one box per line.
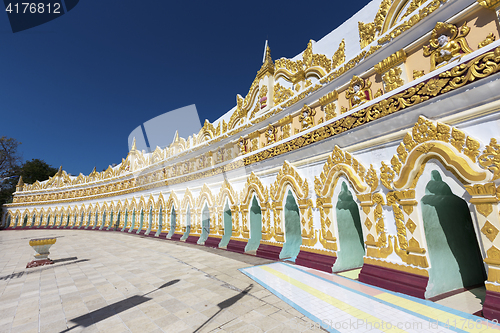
<box><xmin>0</xmin><ymin>0</ymin><xmax>369</xmax><ymax>175</ymax></box>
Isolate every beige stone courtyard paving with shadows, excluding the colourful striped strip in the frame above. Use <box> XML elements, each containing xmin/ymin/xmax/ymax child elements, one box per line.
<box><xmin>0</xmin><ymin>229</ymin><xmax>319</xmax><ymax>333</ymax></box>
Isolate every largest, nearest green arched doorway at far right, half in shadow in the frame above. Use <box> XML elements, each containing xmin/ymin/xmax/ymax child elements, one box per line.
<box><xmin>420</xmin><ymin>170</ymin><xmax>486</xmax><ymax>298</ymax></box>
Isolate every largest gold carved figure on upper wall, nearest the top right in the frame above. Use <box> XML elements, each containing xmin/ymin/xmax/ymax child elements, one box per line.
<box><xmin>424</xmin><ymin>22</ymin><xmax>472</xmax><ymax>71</ymax></box>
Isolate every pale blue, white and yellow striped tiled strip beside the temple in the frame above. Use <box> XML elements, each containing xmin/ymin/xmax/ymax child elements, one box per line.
<box><xmin>241</xmin><ymin>263</ymin><xmax>500</xmax><ymax>332</ymax></box>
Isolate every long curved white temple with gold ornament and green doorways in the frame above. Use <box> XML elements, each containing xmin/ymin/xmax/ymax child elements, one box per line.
<box><xmin>2</xmin><ymin>0</ymin><xmax>500</xmax><ymax>319</ymax></box>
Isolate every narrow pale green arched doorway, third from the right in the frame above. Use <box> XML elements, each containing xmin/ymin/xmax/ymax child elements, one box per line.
<box><xmin>280</xmin><ymin>190</ymin><xmax>302</xmax><ymax>261</ymax></box>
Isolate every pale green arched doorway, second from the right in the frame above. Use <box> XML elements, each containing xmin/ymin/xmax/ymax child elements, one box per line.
<box><xmin>333</xmin><ymin>182</ymin><xmax>365</xmax><ymax>272</ymax></box>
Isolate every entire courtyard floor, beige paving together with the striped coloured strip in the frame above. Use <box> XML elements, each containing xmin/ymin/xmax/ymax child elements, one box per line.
<box><xmin>0</xmin><ymin>229</ymin><xmax>498</xmax><ymax>333</ymax></box>
